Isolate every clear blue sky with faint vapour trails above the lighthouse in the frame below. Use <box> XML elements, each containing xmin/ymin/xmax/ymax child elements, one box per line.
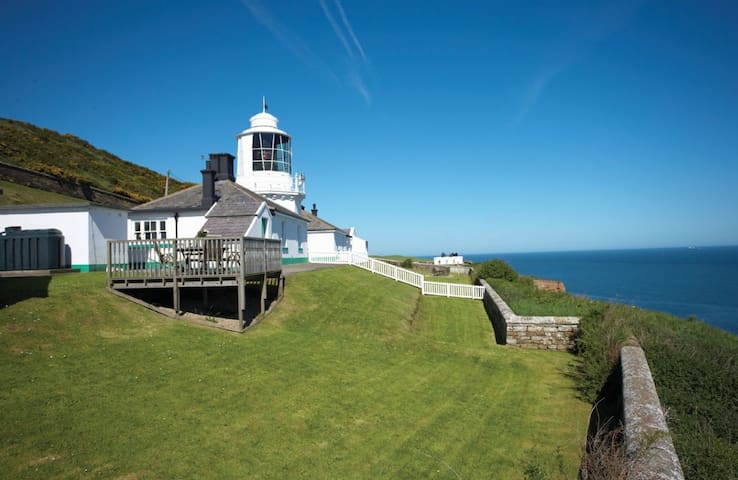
<box><xmin>0</xmin><ymin>0</ymin><xmax>738</xmax><ymax>254</ymax></box>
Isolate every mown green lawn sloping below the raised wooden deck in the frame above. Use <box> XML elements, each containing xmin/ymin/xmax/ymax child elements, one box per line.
<box><xmin>0</xmin><ymin>267</ymin><xmax>589</xmax><ymax>479</ymax></box>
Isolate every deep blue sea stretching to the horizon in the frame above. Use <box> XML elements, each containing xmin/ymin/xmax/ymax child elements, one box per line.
<box><xmin>464</xmin><ymin>246</ymin><xmax>738</xmax><ymax>334</ymax></box>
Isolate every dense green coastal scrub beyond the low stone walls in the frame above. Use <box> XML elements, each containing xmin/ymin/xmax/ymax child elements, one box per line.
<box><xmin>478</xmin><ymin>262</ymin><xmax>738</xmax><ymax>479</ymax></box>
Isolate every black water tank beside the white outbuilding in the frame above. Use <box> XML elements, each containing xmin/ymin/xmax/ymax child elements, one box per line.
<box><xmin>0</xmin><ymin>227</ymin><xmax>65</xmax><ymax>271</ymax></box>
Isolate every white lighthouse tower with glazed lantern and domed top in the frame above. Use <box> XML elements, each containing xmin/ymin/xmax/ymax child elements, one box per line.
<box><xmin>236</xmin><ymin>99</ymin><xmax>305</xmax><ymax>215</ymax></box>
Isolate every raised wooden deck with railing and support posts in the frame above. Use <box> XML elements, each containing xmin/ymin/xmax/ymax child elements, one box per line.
<box><xmin>107</xmin><ymin>237</ymin><xmax>282</xmax><ymax>327</ymax></box>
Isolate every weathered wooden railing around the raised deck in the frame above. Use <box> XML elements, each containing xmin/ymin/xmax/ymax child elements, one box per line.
<box><xmin>107</xmin><ymin>237</ymin><xmax>282</xmax><ymax>283</ymax></box>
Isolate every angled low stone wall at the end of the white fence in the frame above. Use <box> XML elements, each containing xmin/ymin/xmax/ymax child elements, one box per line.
<box><xmin>479</xmin><ymin>279</ymin><xmax>579</xmax><ymax>350</ymax></box>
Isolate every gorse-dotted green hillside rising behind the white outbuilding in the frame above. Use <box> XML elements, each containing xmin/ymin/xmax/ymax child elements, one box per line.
<box><xmin>0</xmin><ymin>118</ymin><xmax>191</xmax><ymax>202</ymax></box>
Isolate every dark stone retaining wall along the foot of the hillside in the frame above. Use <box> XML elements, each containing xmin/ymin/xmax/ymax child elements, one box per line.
<box><xmin>0</xmin><ymin>162</ymin><xmax>139</xmax><ymax>208</ymax></box>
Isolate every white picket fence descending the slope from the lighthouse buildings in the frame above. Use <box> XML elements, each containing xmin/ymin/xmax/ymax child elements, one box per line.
<box><xmin>308</xmin><ymin>252</ymin><xmax>484</xmax><ymax>300</ymax></box>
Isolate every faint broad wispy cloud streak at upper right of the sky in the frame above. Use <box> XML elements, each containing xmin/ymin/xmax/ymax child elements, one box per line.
<box><xmin>510</xmin><ymin>0</ymin><xmax>643</xmax><ymax>127</ymax></box>
